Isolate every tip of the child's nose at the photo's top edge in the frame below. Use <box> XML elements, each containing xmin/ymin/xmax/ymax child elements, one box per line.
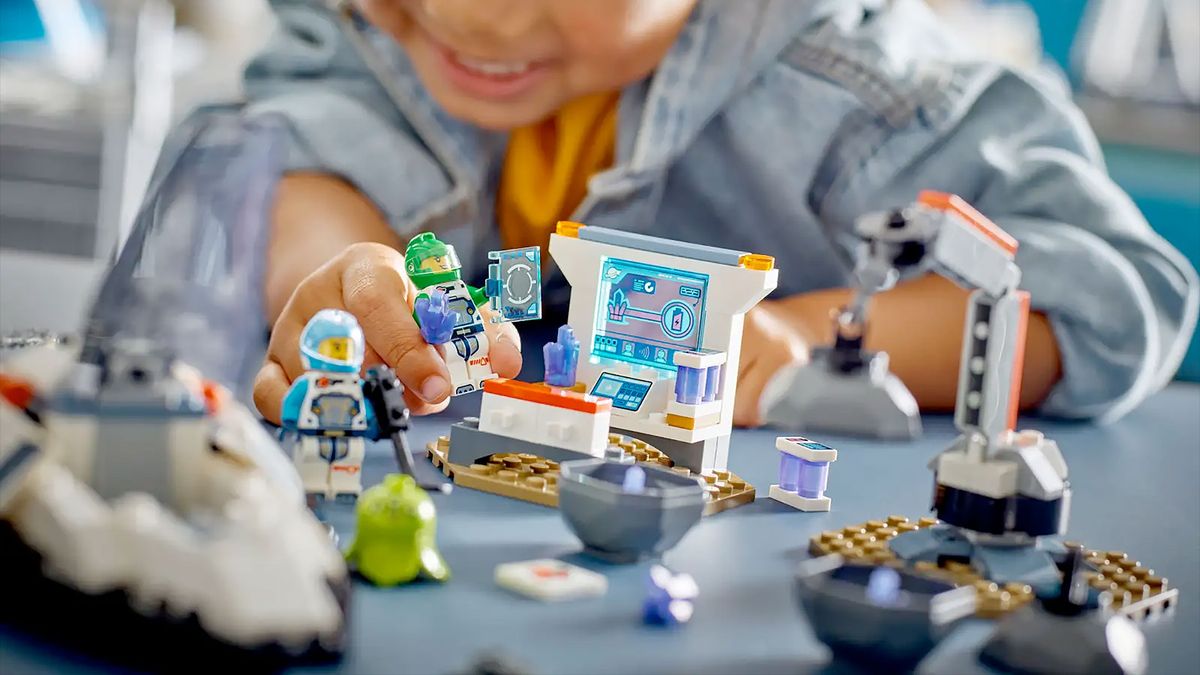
<box><xmin>421</xmin><ymin>0</ymin><xmax>545</xmax><ymax>43</ymax></box>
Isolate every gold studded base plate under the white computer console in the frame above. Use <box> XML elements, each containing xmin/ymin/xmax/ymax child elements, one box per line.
<box><xmin>425</xmin><ymin>434</ymin><xmax>755</xmax><ymax>515</ymax></box>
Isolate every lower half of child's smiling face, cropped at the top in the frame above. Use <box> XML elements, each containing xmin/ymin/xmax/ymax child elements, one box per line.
<box><xmin>359</xmin><ymin>0</ymin><xmax>696</xmax><ymax>129</ymax></box>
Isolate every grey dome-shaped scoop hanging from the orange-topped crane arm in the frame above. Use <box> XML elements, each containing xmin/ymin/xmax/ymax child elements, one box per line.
<box><xmin>764</xmin><ymin>348</ymin><xmax>922</xmax><ymax>440</ymax></box>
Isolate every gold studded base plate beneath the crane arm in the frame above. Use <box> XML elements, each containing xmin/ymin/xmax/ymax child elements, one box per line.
<box><xmin>809</xmin><ymin>515</ymin><xmax>1180</xmax><ymax>620</ymax></box>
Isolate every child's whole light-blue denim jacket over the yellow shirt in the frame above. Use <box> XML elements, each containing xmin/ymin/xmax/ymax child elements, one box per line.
<box><xmin>245</xmin><ymin>0</ymin><xmax>1198</xmax><ymax>418</ymax></box>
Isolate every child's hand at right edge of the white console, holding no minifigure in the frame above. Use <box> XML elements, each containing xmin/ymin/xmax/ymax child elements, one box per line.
<box><xmin>733</xmin><ymin>300</ymin><xmax>810</xmax><ymax>426</ymax></box>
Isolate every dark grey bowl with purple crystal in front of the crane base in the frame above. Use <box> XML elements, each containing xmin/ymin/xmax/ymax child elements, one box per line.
<box><xmin>796</xmin><ymin>555</ymin><xmax>976</xmax><ymax>669</ymax></box>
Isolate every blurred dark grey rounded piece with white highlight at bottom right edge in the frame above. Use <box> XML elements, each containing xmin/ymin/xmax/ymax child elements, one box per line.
<box><xmin>979</xmin><ymin>607</ymin><xmax>1147</xmax><ymax>675</ymax></box>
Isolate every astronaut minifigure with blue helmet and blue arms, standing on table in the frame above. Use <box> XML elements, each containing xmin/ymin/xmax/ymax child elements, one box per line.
<box><xmin>283</xmin><ymin>310</ymin><xmax>376</xmax><ymax>498</ymax></box>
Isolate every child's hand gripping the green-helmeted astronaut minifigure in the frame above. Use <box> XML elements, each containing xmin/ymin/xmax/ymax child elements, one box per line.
<box><xmin>254</xmin><ymin>244</ymin><xmax>521</xmax><ymax>423</ymax></box>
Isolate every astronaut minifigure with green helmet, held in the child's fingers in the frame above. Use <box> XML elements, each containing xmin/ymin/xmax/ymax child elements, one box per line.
<box><xmin>404</xmin><ymin>232</ymin><xmax>496</xmax><ymax>396</ymax></box>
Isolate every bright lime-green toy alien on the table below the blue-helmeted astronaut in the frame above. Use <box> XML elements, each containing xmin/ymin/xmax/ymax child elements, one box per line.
<box><xmin>346</xmin><ymin>473</ymin><xmax>450</xmax><ymax>586</ymax></box>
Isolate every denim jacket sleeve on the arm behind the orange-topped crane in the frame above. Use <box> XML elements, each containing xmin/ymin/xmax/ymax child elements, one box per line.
<box><xmin>829</xmin><ymin>64</ymin><xmax>1198</xmax><ymax>419</ymax></box>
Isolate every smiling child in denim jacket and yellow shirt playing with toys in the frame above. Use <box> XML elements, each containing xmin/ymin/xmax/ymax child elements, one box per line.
<box><xmin>246</xmin><ymin>0</ymin><xmax>1198</xmax><ymax>425</ymax></box>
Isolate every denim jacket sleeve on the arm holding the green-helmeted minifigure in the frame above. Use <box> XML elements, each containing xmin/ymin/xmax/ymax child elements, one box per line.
<box><xmin>244</xmin><ymin>0</ymin><xmax>449</xmax><ymax>226</ymax></box>
